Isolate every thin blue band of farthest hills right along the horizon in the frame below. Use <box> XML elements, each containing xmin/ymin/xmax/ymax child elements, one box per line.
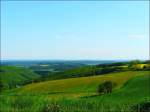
<box><xmin>1</xmin><ymin>60</ymin><xmax>115</xmax><ymax>67</ymax></box>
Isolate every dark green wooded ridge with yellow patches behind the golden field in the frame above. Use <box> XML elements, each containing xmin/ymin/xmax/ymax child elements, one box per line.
<box><xmin>47</xmin><ymin>61</ymin><xmax>150</xmax><ymax>80</ymax></box>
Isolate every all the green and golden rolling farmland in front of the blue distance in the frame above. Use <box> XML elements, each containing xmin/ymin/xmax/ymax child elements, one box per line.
<box><xmin>0</xmin><ymin>62</ymin><xmax>150</xmax><ymax>112</ymax></box>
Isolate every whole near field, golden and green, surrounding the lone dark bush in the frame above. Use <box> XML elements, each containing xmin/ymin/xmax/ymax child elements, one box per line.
<box><xmin>0</xmin><ymin>71</ymin><xmax>150</xmax><ymax>112</ymax></box>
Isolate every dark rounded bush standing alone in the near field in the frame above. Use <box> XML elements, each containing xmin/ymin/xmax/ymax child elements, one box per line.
<box><xmin>97</xmin><ymin>81</ymin><xmax>115</xmax><ymax>94</ymax></box>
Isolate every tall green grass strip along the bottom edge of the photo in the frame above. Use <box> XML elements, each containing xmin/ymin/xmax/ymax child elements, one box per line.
<box><xmin>0</xmin><ymin>96</ymin><xmax>133</xmax><ymax>112</ymax></box>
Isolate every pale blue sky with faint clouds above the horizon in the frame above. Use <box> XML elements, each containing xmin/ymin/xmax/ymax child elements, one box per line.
<box><xmin>1</xmin><ymin>1</ymin><xmax>149</xmax><ymax>60</ymax></box>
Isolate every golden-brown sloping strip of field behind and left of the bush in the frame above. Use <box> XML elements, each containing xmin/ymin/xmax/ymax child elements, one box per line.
<box><xmin>16</xmin><ymin>71</ymin><xmax>149</xmax><ymax>96</ymax></box>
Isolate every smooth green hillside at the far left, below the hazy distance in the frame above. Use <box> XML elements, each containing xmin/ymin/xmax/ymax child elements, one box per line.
<box><xmin>0</xmin><ymin>66</ymin><xmax>39</xmax><ymax>89</ymax></box>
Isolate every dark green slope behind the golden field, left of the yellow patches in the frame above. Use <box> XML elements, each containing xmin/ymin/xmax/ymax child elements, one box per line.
<box><xmin>48</xmin><ymin>65</ymin><xmax>123</xmax><ymax>80</ymax></box>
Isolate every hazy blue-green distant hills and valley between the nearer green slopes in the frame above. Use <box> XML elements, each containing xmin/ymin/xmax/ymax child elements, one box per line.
<box><xmin>1</xmin><ymin>60</ymin><xmax>115</xmax><ymax>78</ymax></box>
